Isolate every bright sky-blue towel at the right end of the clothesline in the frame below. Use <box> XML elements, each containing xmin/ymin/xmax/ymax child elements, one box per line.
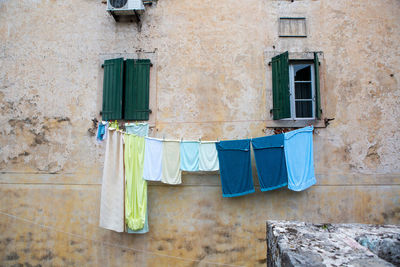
<box><xmin>284</xmin><ymin>126</ymin><xmax>317</xmax><ymax>191</ymax></box>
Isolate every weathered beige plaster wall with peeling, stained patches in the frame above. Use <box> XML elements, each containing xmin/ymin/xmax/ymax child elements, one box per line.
<box><xmin>0</xmin><ymin>0</ymin><xmax>400</xmax><ymax>266</ymax></box>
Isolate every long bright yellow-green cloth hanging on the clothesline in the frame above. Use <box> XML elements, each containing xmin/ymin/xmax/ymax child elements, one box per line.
<box><xmin>124</xmin><ymin>134</ymin><xmax>147</xmax><ymax>231</ymax></box>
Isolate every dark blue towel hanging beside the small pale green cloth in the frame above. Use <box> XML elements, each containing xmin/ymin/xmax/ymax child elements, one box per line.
<box><xmin>215</xmin><ymin>139</ymin><xmax>254</xmax><ymax>197</ymax></box>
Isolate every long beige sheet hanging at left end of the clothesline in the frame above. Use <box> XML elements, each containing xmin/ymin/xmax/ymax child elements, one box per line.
<box><xmin>100</xmin><ymin>130</ymin><xmax>124</xmax><ymax>232</ymax></box>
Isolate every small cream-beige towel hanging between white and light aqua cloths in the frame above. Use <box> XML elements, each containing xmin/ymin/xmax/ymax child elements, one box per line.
<box><xmin>161</xmin><ymin>141</ymin><xmax>182</xmax><ymax>184</ymax></box>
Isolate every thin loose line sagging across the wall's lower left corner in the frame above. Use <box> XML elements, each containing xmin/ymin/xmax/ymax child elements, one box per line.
<box><xmin>0</xmin><ymin>211</ymin><xmax>243</xmax><ymax>267</ymax></box>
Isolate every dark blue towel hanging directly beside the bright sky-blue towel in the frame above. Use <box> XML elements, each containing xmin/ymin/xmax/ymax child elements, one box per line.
<box><xmin>251</xmin><ymin>134</ymin><xmax>288</xmax><ymax>191</ymax></box>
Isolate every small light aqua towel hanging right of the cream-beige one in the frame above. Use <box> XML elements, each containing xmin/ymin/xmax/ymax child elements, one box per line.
<box><xmin>180</xmin><ymin>141</ymin><xmax>200</xmax><ymax>172</ymax></box>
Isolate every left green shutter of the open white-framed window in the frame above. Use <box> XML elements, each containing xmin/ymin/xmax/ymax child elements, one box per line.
<box><xmin>272</xmin><ymin>52</ymin><xmax>291</xmax><ymax>120</ymax></box>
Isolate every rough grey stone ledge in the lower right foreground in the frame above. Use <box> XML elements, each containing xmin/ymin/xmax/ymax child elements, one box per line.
<box><xmin>267</xmin><ymin>221</ymin><xmax>400</xmax><ymax>267</ymax></box>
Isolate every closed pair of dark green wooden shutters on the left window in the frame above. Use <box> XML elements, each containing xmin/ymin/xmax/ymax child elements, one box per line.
<box><xmin>102</xmin><ymin>58</ymin><xmax>151</xmax><ymax>121</ymax></box>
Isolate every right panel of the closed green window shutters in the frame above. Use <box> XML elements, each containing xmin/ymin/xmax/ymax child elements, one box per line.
<box><xmin>124</xmin><ymin>59</ymin><xmax>151</xmax><ymax>121</ymax></box>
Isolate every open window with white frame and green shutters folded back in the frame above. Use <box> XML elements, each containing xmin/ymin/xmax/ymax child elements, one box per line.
<box><xmin>271</xmin><ymin>52</ymin><xmax>321</xmax><ymax>120</ymax></box>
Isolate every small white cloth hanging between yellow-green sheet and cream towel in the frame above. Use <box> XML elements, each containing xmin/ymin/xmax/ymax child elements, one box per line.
<box><xmin>143</xmin><ymin>138</ymin><xmax>163</xmax><ymax>181</ymax></box>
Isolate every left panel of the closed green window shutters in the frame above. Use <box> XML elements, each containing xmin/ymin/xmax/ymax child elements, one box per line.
<box><xmin>102</xmin><ymin>58</ymin><xmax>124</xmax><ymax>121</ymax></box>
